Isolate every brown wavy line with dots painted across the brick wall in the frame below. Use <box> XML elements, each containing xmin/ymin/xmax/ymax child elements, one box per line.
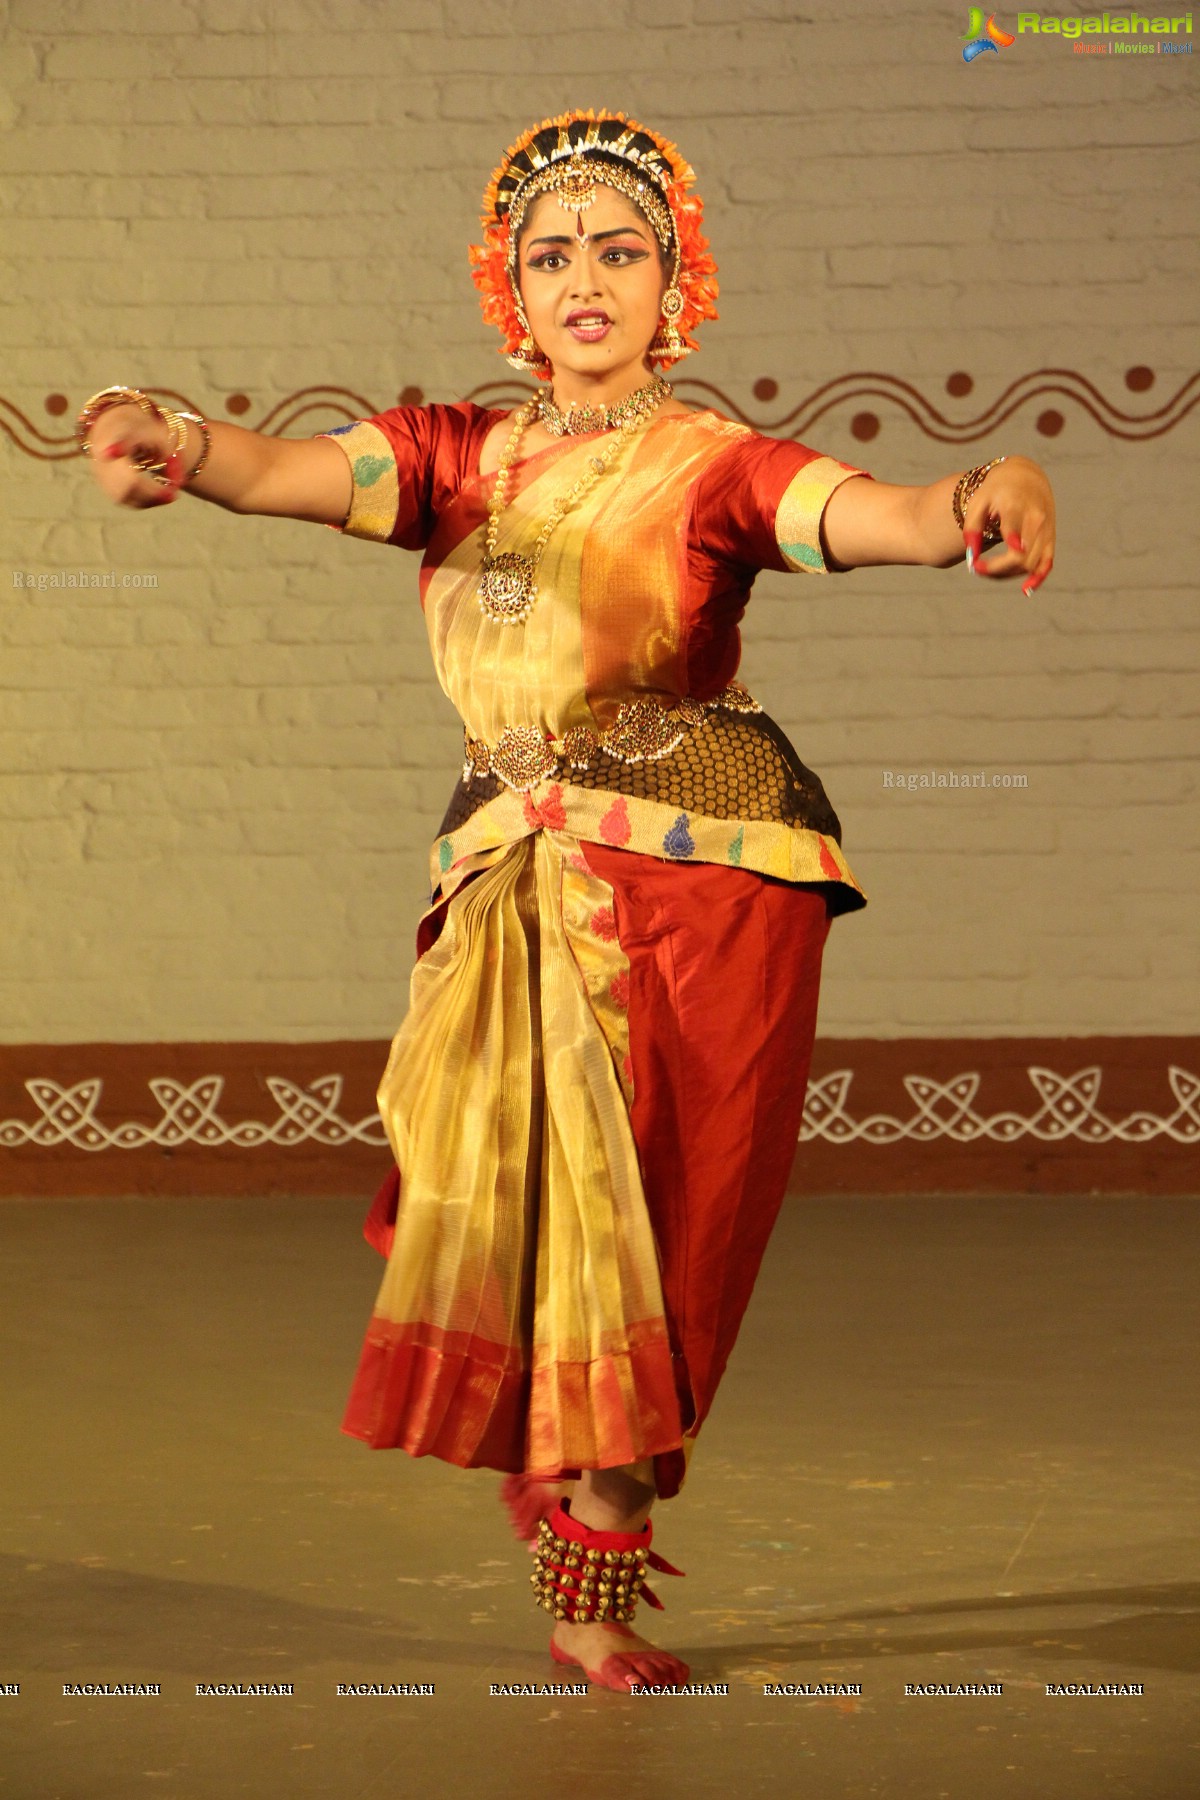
<box><xmin>0</xmin><ymin>364</ymin><xmax>1200</xmax><ymax>463</ymax></box>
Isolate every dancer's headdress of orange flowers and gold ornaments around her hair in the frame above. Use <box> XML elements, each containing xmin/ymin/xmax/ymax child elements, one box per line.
<box><xmin>471</xmin><ymin>112</ymin><xmax>718</xmax><ymax>380</ymax></box>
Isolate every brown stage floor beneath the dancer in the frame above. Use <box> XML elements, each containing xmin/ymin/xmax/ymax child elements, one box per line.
<box><xmin>0</xmin><ymin>1197</ymin><xmax>1200</xmax><ymax>1800</ymax></box>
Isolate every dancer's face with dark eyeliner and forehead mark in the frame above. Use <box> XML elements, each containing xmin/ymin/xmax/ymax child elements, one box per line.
<box><xmin>518</xmin><ymin>182</ymin><xmax>669</xmax><ymax>389</ymax></box>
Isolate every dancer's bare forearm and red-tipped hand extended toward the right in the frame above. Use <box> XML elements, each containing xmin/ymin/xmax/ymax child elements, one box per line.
<box><xmin>820</xmin><ymin>455</ymin><xmax>1054</xmax><ymax>594</ymax></box>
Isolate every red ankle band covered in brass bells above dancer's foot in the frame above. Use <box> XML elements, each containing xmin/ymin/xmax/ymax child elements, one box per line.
<box><xmin>529</xmin><ymin>1499</ymin><xmax>684</xmax><ymax>1625</ymax></box>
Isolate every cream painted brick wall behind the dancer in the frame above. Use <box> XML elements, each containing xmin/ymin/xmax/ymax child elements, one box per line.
<box><xmin>0</xmin><ymin>0</ymin><xmax>1200</xmax><ymax>1042</ymax></box>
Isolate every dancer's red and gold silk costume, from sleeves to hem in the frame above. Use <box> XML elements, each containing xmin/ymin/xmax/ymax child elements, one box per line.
<box><xmin>331</xmin><ymin>403</ymin><xmax>864</xmax><ymax>1496</ymax></box>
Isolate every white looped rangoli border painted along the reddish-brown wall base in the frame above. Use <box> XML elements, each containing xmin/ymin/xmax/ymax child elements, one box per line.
<box><xmin>0</xmin><ymin>1064</ymin><xmax>1200</xmax><ymax>1150</ymax></box>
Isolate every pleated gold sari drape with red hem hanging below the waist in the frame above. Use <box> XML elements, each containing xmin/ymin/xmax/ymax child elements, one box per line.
<box><xmin>347</xmin><ymin>830</ymin><xmax>682</xmax><ymax>1474</ymax></box>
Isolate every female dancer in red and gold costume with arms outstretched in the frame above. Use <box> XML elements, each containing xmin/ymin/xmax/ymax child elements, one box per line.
<box><xmin>79</xmin><ymin>112</ymin><xmax>1054</xmax><ymax>1688</ymax></box>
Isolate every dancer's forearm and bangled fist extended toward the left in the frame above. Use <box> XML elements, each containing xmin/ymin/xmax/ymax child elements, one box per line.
<box><xmin>88</xmin><ymin>403</ymin><xmax>351</xmax><ymax>526</ymax></box>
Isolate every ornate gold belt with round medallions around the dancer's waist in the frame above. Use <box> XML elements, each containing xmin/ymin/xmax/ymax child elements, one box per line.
<box><xmin>462</xmin><ymin>680</ymin><xmax>763</xmax><ymax>794</ymax></box>
